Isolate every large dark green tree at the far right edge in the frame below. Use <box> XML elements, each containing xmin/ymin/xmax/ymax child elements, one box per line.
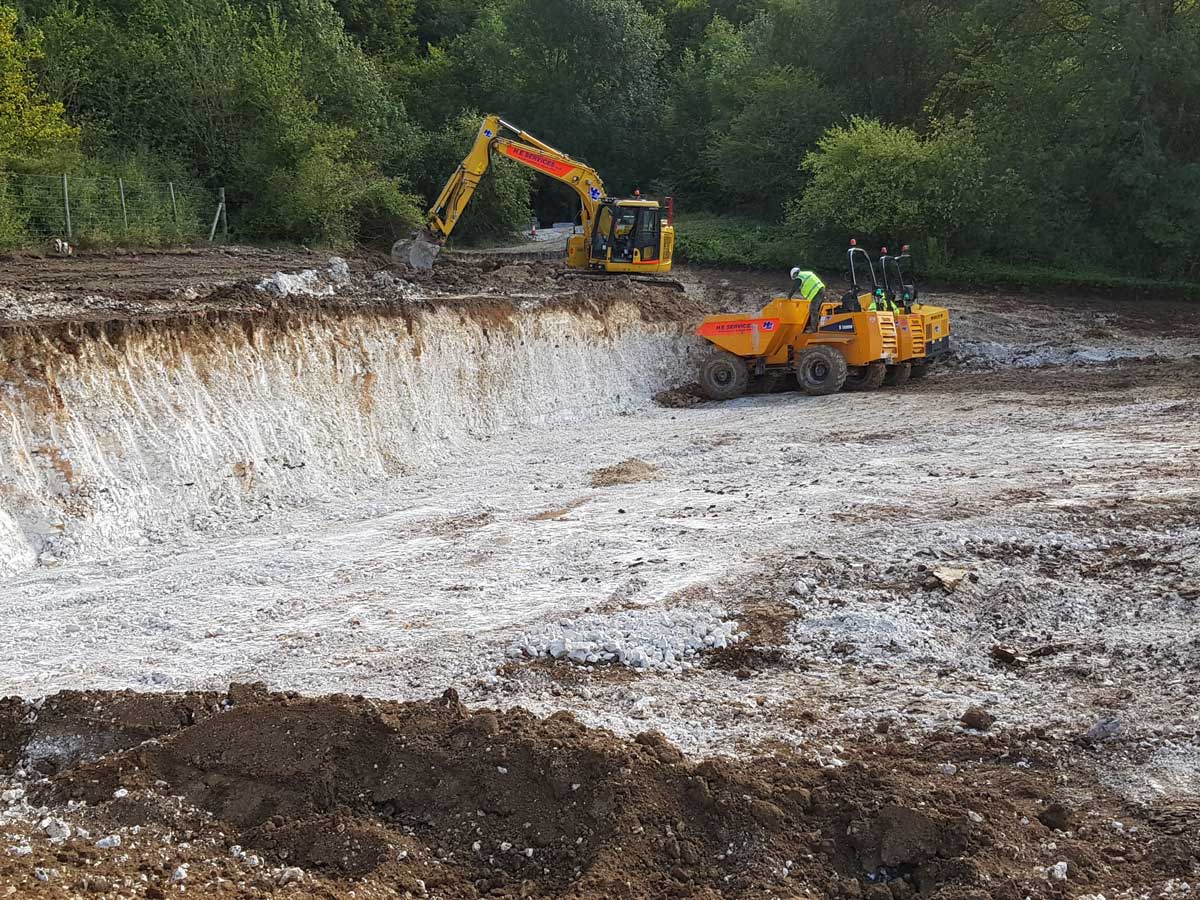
<box><xmin>929</xmin><ymin>0</ymin><xmax>1200</xmax><ymax>274</ymax></box>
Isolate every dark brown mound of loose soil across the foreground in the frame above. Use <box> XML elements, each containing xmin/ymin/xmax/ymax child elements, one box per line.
<box><xmin>0</xmin><ymin>685</ymin><xmax>1198</xmax><ymax>900</ymax></box>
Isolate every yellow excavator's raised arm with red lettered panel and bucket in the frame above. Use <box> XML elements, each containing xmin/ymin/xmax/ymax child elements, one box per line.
<box><xmin>392</xmin><ymin>115</ymin><xmax>605</xmax><ymax>269</ymax></box>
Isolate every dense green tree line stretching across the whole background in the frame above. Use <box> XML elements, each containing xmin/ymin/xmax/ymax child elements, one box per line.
<box><xmin>0</xmin><ymin>0</ymin><xmax>1200</xmax><ymax>277</ymax></box>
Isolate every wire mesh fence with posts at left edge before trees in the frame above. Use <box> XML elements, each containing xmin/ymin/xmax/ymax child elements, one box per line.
<box><xmin>0</xmin><ymin>172</ymin><xmax>228</xmax><ymax>245</ymax></box>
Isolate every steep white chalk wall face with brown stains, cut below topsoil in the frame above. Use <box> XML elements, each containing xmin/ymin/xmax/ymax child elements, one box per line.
<box><xmin>0</xmin><ymin>300</ymin><xmax>698</xmax><ymax>575</ymax></box>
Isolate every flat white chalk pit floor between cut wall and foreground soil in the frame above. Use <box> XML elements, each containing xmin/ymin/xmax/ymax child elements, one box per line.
<box><xmin>0</xmin><ymin>285</ymin><xmax>1200</xmax><ymax>816</ymax></box>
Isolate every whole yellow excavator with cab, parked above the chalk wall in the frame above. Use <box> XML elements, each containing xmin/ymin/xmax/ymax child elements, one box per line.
<box><xmin>391</xmin><ymin>115</ymin><xmax>674</xmax><ymax>275</ymax></box>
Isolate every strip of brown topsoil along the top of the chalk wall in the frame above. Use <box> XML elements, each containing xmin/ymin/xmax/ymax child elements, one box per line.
<box><xmin>0</xmin><ymin>248</ymin><xmax>706</xmax><ymax>329</ymax></box>
